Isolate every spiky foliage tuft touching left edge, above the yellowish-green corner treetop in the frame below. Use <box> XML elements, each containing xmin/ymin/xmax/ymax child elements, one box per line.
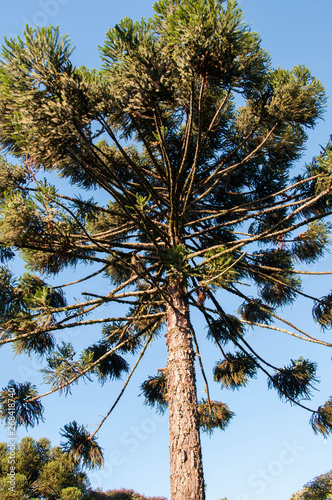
<box><xmin>0</xmin><ymin>380</ymin><xmax>44</xmax><ymax>429</ymax></box>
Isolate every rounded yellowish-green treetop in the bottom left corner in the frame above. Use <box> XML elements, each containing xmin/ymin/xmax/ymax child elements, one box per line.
<box><xmin>0</xmin><ymin>437</ymin><xmax>89</xmax><ymax>500</ymax></box>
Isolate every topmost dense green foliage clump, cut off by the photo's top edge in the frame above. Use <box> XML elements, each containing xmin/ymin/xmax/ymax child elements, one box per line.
<box><xmin>154</xmin><ymin>0</ymin><xmax>269</xmax><ymax>96</ymax></box>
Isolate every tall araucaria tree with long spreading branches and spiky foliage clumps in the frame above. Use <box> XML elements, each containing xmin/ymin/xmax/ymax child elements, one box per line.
<box><xmin>0</xmin><ymin>0</ymin><xmax>332</xmax><ymax>500</ymax></box>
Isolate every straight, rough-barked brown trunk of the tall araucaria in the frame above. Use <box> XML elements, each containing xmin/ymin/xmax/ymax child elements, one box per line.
<box><xmin>167</xmin><ymin>284</ymin><xmax>205</xmax><ymax>500</ymax></box>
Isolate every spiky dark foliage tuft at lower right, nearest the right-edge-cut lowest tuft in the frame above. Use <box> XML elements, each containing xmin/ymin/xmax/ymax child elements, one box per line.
<box><xmin>268</xmin><ymin>357</ymin><xmax>318</xmax><ymax>400</ymax></box>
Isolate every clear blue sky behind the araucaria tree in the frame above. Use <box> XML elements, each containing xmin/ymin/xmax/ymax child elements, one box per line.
<box><xmin>0</xmin><ymin>0</ymin><xmax>332</xmax><ymax>500</ymax></box>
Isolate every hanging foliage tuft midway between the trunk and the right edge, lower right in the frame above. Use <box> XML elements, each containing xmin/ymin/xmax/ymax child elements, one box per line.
<box><xmin>213</xmin><ymin>352</ymin><xmax>257</xmax><ymax>389</ymax></box>
